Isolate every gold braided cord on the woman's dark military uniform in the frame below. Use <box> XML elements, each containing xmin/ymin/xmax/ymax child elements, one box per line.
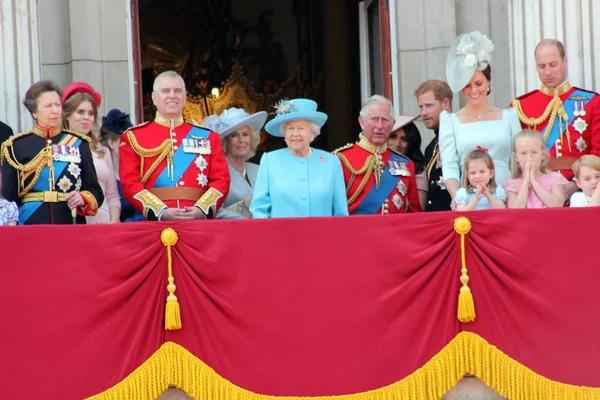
<box><xmin>1</xmin><ymin>131</ymin><xmax>52</xmax><ymax>198</ymax></box>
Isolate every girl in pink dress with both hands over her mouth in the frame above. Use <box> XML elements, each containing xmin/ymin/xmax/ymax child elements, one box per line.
<box><xmin>504</xmin><ymin>129</ymin><xmax>568</xmax><ymax>208</ymax></box>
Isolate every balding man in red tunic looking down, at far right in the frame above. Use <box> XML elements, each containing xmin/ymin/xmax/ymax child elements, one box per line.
<box><xmin>512</xmin><ymin>39</ymin><xmax>600</xmax><ymax>197</ymax></box>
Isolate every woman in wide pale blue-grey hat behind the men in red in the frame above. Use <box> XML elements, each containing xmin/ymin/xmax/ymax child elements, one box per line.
<box><xmin>203</xmin><ymin>107</ymin><xmax>267</xmax><ymax>219</ymax></box>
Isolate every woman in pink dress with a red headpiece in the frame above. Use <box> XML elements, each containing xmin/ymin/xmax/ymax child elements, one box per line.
<box><xmin>62</xmin><ymin>82</ymin><xmax>121</xmax><ymax>224</ymax></box>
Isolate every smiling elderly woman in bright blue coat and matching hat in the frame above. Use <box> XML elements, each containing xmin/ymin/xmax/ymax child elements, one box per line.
<box><xmin>250</xmin><ymin>99</ymin><xmax>348</xmax><ymax>218</ymax></box>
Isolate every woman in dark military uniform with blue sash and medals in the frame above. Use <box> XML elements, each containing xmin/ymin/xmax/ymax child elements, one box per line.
<box><xmin>1</xmin><ymin>81</ymin><xmax>104</xmax><ymax>225</ymax></box>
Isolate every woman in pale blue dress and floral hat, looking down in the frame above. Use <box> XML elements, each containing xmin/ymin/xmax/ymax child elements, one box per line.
<box><xmin>439</xmin><ymin>32</ymin><xmax>521</xmax><ymax>200</ymax></box>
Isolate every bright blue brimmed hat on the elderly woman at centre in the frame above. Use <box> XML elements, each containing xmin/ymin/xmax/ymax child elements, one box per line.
<box><xmin>265</xmin><ymin>99</ymin><xmax>327</xmax><ymax>137</ymax></box>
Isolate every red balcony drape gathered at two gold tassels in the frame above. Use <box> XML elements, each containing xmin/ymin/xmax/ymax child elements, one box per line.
<box><xmin>0</xmin><ymin>209</ymin><xmax>600</xmax><ymax>399</ymax></box>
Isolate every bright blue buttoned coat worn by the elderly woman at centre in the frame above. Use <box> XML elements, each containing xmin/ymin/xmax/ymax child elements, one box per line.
<box><xmin>250</xmin><ymin>148</ymin><xmax>348</xmax><ymax>218</ymax></box>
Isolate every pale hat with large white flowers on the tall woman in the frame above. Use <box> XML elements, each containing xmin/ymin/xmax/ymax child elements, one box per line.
<box><xmin>446</xmin><ymin>31</ymin><xmax>494</xmax><ymax>93</ymax></box>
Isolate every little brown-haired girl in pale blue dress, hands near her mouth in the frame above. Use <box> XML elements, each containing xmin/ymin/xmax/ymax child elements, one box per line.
<box><xmin>454</xmin><ymin>146</ymin><xmax>506</xmax><ymax>211</ymax></box>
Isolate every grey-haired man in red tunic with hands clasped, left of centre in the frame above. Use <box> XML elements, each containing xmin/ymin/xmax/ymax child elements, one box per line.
<box><xmin>119</xmin><ymin>71</ymin><xmax>230</xmax><ymax>221</ymax></box>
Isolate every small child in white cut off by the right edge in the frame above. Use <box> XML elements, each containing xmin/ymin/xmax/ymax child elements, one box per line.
<box><xmin>569</xmin><ymin>154</ymin><xmax>600</xmax><ymax>207</ymax></box>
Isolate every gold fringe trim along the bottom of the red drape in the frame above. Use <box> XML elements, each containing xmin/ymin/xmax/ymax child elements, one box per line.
<box><xmin>89</xmin><ymin>332</ymin><xmax>600</xmax><ymax>400</ymax></box>
